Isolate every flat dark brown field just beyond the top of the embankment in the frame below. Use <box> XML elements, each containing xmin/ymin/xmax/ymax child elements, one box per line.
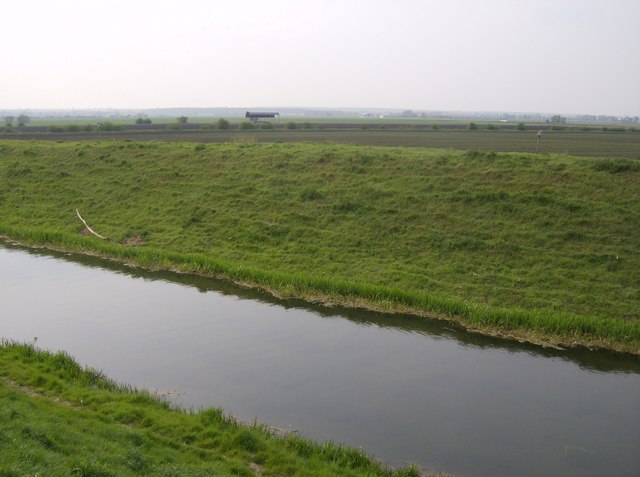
<box><xmin>0</xmin><ymin>121</ymin><xmax>640</xmax><ymax>159</ymax></box>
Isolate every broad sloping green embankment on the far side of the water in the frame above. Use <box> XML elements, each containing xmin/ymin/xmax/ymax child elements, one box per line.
<box><xmin>0</xmin><ymin>141</ymin><xmax>640</xmax><ymax>353</ymax></box>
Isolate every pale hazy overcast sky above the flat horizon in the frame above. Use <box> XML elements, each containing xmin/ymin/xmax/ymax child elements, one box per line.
<box><xmin>0</xmin><ymin>0</ymin><xmax>640</xmax><ymax>116</ymax></box>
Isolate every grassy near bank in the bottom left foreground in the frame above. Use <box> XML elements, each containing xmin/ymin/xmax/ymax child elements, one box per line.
<box><xmin>0</xmin><ymin>342</ymin><xmax>420</xmax><ymax>477</ymax></box>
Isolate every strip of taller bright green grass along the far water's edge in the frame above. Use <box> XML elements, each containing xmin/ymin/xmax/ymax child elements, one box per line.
<box><xmin>0</xmin><ymin>223</ymin><xmax>640</xmax><ymax>356</ymax></box>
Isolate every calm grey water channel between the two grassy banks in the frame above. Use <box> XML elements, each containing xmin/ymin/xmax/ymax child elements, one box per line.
<box><xmin>0</xmin><ymin>243</ymin><xmax>640</xmax><ymax>477</ymax></box>
